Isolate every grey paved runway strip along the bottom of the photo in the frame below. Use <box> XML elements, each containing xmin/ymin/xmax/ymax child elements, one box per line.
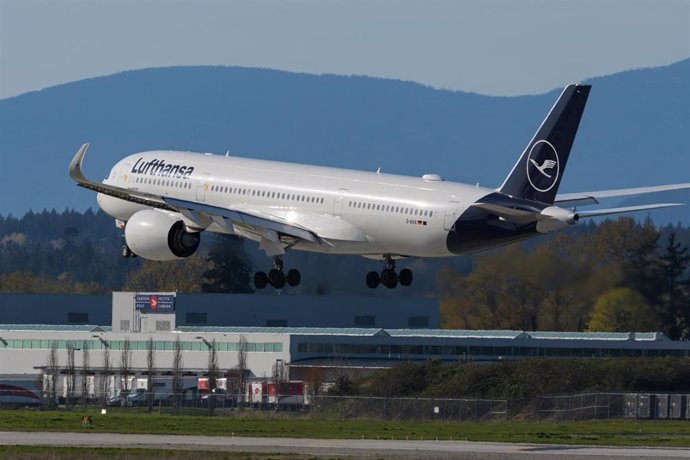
<box><xmin>0</xmin><ymin>432</ymin><xmax>690</xmax><ymax>460</ymax></box>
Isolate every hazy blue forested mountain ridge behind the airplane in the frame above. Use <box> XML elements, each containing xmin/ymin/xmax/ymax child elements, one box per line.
<box><xmin>0</xmin><ymin>59</ymin><xmax>690</xmax><ymax>222</ymax></box>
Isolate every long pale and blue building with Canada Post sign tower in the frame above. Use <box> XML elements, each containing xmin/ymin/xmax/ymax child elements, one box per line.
<box><xmin>0</xmin><ymin>292</ymin><xmax>690</xmax><ymax>400</ymax></box>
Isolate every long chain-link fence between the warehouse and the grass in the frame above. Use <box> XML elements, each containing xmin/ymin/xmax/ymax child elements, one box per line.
<box><xmin>0</xmin><ymin>390</ymin><xmax>690</xmax><ymax>422</ymax></box>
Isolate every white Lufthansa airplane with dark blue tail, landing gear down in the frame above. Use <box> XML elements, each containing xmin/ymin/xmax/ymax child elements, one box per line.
<box><xmin>69</xmin><ymin>84</ymin><xmax>690</xmax><ymax>289</ymax></box>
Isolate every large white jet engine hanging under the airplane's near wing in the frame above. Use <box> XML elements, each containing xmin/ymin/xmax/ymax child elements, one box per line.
<box><xmin>125</xmin><ymin>209</ymin><xmax>201</xmax><ymax>260</ymax></box>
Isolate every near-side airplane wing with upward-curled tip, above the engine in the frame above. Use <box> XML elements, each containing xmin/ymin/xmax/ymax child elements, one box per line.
<box><xmin>69</xmin><ymin>144</ymin><xmax>350</xmax><ymax>248</ymax></box>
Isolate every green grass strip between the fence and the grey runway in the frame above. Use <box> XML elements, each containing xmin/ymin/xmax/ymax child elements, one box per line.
<box><xmin>0</xmin><ymin>410</ymin><xmax>690</xmax><ymax>448</ymax></box>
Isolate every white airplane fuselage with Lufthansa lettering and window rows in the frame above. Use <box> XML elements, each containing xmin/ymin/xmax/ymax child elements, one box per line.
<box><xmin>98</xmin><ymin>151</ymin><xmax>495</xmax><ymax>257</ymax></box>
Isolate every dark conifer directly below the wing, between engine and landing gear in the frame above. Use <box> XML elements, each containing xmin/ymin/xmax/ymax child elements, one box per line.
<box><xmin>202</xmin><ymin>235</ymin><xmax>254</xmax><ymax>294</ymax></box>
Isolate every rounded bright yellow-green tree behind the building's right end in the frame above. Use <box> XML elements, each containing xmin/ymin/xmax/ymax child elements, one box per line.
<box><xmin>587</xmin><ymin>288</ymin><xmax>659</xmax><ymax>332</ymax></box>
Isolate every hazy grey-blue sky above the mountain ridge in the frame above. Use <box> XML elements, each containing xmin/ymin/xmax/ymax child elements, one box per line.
<box><xmin>0</xmin><ymin>0</ymin><xmax>690</xmax><ymax>98</ymax></box>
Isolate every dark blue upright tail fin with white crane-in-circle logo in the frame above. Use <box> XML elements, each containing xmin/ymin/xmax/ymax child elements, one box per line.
<box><xmin>500</xmin><ymin>85</ymin><xmax>591</xmax><ymax>204</ymax></box>
